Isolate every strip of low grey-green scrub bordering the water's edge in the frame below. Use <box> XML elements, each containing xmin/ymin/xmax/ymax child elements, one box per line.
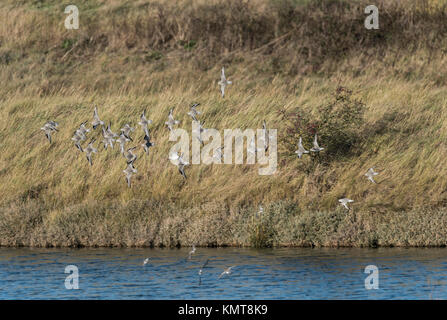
<box><xmin>0</xmin><ymin>200</ymin><xmax>447</xmax><ymax>248</ymax></box>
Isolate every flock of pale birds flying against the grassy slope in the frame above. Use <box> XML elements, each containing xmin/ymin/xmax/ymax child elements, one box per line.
<box><xmin>41</xmin><ymin>68</ymin><xmax>379</xmax><ymax>210</ymax></box>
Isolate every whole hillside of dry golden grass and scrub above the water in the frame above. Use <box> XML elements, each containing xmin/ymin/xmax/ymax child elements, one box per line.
<box><xmin>0</xmin><ymin>0</ymin><xmax>447</xmax><ymax>246</ymax></box>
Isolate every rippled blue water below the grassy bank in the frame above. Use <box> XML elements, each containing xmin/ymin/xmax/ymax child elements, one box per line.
<box><xmin>0</xmin><ymin>248</ymin><xmax>447</xmax><ymax>299</ymax></box>
